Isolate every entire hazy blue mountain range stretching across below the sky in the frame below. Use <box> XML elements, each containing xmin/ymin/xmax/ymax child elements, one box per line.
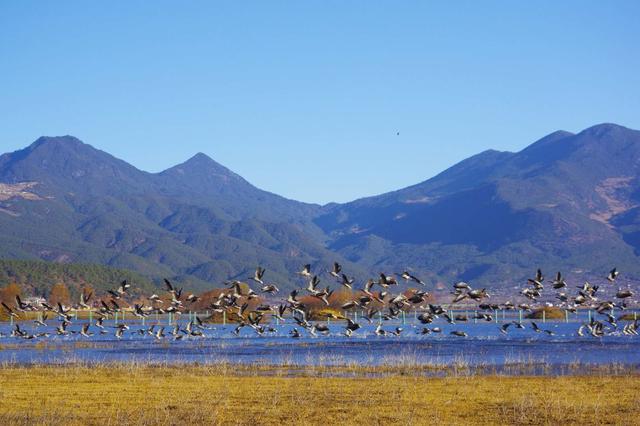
<box><xmin>0</xmin><ymin>124</ymin><xmax>640</xmax><ymax>289</ymax></box>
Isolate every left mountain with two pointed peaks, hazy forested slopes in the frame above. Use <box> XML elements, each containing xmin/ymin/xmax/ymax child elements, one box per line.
<box><xmin>0</xmin><ymin>136</ymin><xmax>359</xmax><ymax>289</ymax></box>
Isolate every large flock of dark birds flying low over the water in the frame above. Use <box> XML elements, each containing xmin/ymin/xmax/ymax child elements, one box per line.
<box><xmin>0</xmin><ymin>263</ymin><xmax>640</xmax><ymax>340</ymax></box>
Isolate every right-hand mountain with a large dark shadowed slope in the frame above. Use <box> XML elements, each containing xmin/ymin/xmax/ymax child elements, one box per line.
<box><xmin>316</xmin><ymin>124</ymin><xmax>640</xmax><ymax>286</ymax></box>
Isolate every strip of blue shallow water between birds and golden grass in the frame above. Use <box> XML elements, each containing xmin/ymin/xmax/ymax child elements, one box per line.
<box><xmin>0</xmin><ymin>321</ymin><xmax>640</xmax><ymax>370</ymax></box>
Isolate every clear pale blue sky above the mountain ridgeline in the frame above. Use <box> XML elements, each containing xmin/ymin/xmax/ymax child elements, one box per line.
<box><xmin>0</xmin><ymin>0</ymin><xmax>640</xmax><ymax>203</ymax></box>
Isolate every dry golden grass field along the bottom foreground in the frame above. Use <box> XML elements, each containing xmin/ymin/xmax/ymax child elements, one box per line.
<box><xmin>0</xmin><ymin>364</ymin><xmax>640</xmax><ymax>425</ymax></box>
